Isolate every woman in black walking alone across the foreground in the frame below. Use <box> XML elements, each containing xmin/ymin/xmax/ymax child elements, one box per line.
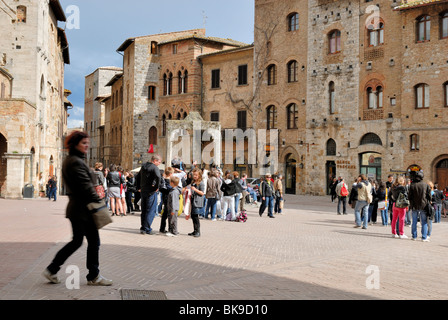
<box><xmin>43</xmin><ymin>131</ymin><xmax>112</xmax><ymax>286</ymax></box>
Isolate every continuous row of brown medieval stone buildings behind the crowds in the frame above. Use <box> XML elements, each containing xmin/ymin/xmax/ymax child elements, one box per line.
<box><xmin>89</xmin><ymin>0</ymin><xmax>448</xmax><ymax>195</ymax></box>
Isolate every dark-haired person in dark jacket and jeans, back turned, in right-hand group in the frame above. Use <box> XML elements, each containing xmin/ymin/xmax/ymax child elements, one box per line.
<box><xmin>409</xmin><ymin>171</ymin><xmax>431</xmax><ymax>242</ymax></box>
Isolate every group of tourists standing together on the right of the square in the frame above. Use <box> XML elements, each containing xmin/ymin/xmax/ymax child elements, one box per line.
<box><xmin>330</xmin><ymin>171</ymin><xmax>448</xmax><ymax>242</ymax></box>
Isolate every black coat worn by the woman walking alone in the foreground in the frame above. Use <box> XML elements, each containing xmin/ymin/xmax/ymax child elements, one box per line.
<box><xmin>62</xmin><ymin>150</ymin><xmax>101</xmax><ymax>221</ymax></box>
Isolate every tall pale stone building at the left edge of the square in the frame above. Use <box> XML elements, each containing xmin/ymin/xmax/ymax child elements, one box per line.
<box><xmin>0</xmin><ymin>0</ymin><xmax>70</xmax><ymax>198</ymax></box>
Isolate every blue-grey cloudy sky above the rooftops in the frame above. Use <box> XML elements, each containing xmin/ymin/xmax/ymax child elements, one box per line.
<box><xmin>59</xmin><ymin>0</ymin><xmax>254</xmax><ymax>128</ymax></box>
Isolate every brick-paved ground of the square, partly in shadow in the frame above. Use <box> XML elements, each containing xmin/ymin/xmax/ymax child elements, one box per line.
<box><xmin>0</xmin><ymin>195</ymin><xmax>448</xmax><ymax>300</ymax></box>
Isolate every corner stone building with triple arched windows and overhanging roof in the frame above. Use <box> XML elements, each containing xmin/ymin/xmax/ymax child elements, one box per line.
<box><xmin>117</xmin><ymin>29</ymin><xmax>247</xmax><ymax>168</ymax></box>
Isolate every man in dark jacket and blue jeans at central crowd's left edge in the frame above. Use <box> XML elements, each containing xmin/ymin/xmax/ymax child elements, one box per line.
<box><xmin>138</xmin><ymin>155</ymin><xmax>162</xmax><ymax>234</ymax></box>
